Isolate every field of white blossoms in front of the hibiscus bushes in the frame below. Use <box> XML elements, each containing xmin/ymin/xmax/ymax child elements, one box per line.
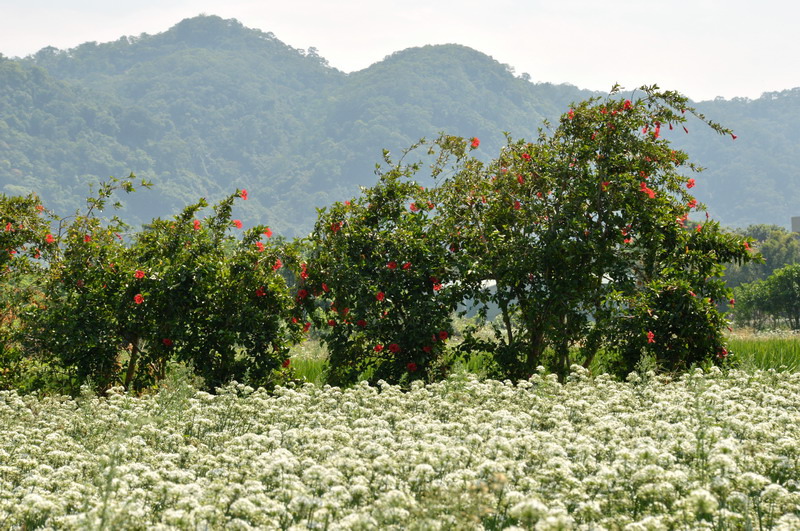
<box><xmin>0</xmin><ymin>369</ymin><xmax>800</xmax><ymax>530</ymax></box>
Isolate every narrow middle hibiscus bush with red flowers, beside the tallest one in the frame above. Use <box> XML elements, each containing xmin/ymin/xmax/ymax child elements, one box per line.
<box><xmin>297</xmin><ymin>149</ymin><xmax>456</xmax><ymax>384</ymax></box>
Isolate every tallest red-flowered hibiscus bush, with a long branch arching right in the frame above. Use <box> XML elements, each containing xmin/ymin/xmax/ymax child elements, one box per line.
<box><xmin>434</xmin><ymin>87</ymin><xmax>754</xmax><ymax>377</ymax></box>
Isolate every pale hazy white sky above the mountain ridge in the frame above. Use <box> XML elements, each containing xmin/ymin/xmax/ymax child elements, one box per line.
<box><xmin>0</xmin><ymin>0</ymin><xmax>800</xmax><ymax>100</ymax></box>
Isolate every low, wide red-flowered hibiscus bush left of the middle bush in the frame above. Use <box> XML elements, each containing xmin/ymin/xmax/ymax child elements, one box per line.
<box><xmin>18</xmin><ymin>181</ymin><xmax>301</xmax><ymax>389</ymax></box>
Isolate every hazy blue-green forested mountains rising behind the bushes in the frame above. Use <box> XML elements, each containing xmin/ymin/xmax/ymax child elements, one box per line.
<box><xmin>0</xmin><ymin>16</ymin><xmax>800</xmax><ymax>236</ymax></box>
